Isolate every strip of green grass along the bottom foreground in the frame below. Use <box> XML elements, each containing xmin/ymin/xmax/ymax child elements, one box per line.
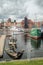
<box><xmin>0</xmin><ymin>60</ymin><xmax>43</xmax><ymax>65</ymax></box>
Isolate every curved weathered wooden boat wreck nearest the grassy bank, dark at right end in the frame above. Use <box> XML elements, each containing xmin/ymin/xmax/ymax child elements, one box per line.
<box><xmin>5</xmin><ymin>49</ymin><xmax>24</xmax><ymax>59</ymax></box>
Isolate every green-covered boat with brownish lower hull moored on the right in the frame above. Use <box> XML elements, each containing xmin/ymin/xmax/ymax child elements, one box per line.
<box><xmin>30</xmin><ymin>28</ymin><xmax>41</xmax><ymax>39</ymax></box>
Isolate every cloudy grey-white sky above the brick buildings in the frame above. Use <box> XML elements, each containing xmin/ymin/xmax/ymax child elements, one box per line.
<box><xmin>0</xmin><ymin>0</ymin><xmax>43</xmax><ymax>21</ymax></box>
